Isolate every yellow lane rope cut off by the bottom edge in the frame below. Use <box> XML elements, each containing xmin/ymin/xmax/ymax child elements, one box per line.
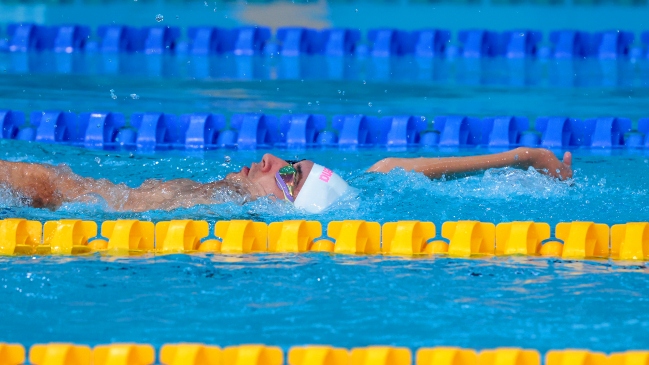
<box><xmin>0</xmin><ymin>342</ymin><xmax>649</xmax><ymax>365</ymax></box>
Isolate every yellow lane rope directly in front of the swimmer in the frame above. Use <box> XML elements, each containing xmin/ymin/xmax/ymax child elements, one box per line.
<box><xmin>0</xmin><ymin>218</ymin><xmax>649</xmax><ymax>260</ymax></box>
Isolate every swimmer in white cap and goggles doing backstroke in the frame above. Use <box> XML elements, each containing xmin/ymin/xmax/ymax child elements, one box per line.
<box><xmin>0</xmin><ymin>147</ymin><xmax>572</xmax><ymax>213</ymax></box>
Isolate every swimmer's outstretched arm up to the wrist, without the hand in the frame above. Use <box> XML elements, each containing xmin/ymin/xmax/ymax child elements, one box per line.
<box><xmin>368</xmin><ymin>148</ymin><xmax>535</xmax><ymax>179</ymax></box>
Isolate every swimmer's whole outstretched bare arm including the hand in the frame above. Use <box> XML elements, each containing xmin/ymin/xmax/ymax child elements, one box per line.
<box><xmin>367</xmin><ymin>147</ymin><xmax>572</xmax><ymax>180</ymax></box>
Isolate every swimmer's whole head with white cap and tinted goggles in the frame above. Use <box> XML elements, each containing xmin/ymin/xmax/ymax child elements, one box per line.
<box><xmin>227</xmin><ymin>153</ymin><xmax>349</xmax><ymax>213</ymax></box>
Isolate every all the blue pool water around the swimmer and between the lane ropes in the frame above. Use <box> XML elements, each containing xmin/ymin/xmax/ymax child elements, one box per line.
<box><xmin>0</xmin><ymin>2</ymin><xmax>649</xmax><ymax>352</ymax></box>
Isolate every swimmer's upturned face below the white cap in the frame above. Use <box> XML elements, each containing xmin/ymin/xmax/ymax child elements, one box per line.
<box><xmin>226</xmin><ymin>153</ymin><xmax>313</xmax><ymax>199</ymax></box>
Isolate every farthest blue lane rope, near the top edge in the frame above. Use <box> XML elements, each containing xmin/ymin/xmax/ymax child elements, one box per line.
<box><xmin>0</xmin><ymin>24</ymin><xmax>649</xmax><ymax>58</ymax></box>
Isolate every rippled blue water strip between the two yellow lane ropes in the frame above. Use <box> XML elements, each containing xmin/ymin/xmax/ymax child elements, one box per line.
<box><xmin>0</xmin><ymin>254</ymin><xmax>649</xmax><ymax>352</ymax></box>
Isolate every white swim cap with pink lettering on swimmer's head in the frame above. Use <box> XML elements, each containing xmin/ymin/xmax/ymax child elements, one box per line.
<box><xmin>293</xmin><ymin>164</ymin><xmax>350</xmax><ymax>213</ymax></box>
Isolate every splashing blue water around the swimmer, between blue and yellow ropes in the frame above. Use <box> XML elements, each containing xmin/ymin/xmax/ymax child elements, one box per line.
<box><xmin>0</xmin><ymin>140</ymin><xmax>649</xmax><ymax>225</ymax></box>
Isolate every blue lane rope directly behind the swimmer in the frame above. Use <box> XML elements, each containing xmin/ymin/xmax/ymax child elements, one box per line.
<box><xmin>0</xmin><ymin>110</ymin><xmax>649</xmax><ymax>149</ymax></box>
